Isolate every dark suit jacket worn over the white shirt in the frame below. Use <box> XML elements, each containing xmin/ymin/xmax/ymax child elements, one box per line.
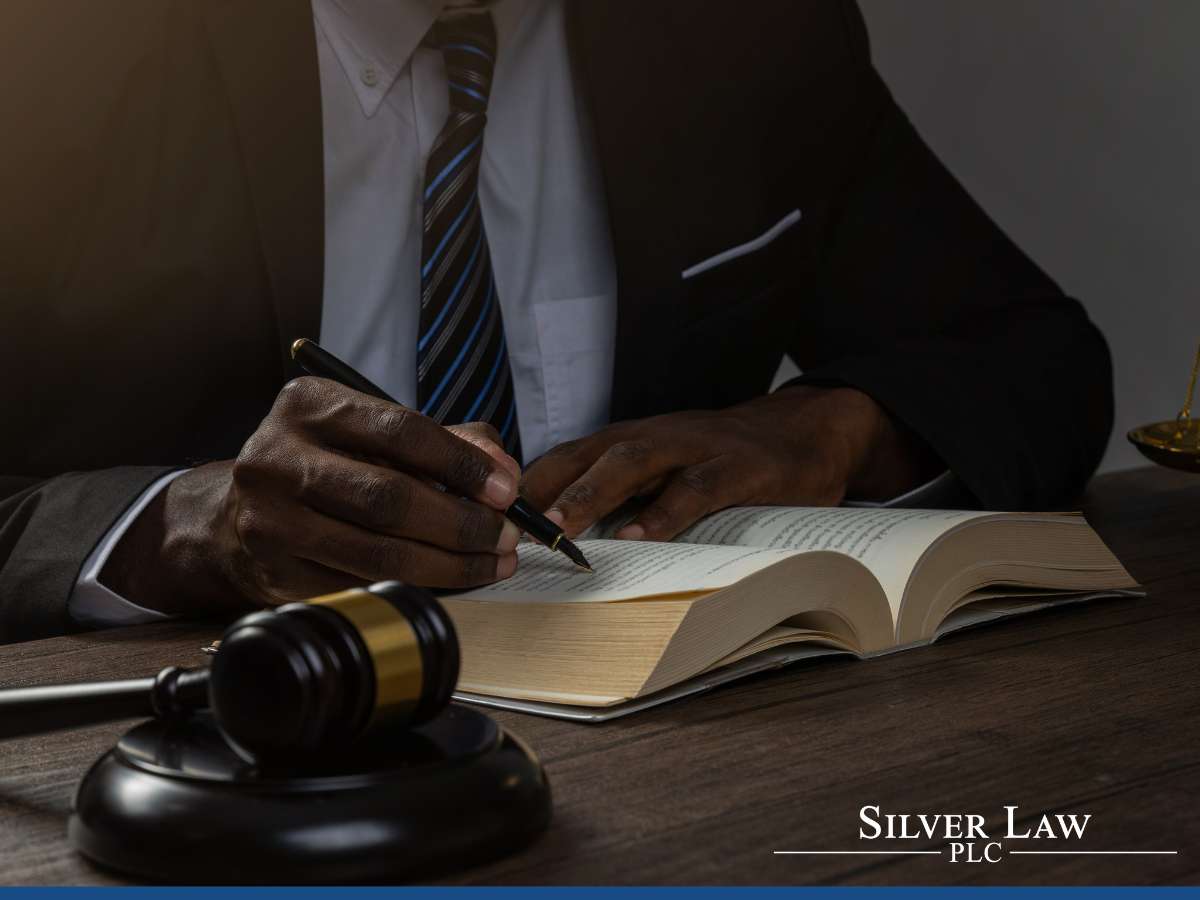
<box><xmin>0</xmin><ymin>0</ymin><xmax>1111</xmax><ymax>641</ymax></box>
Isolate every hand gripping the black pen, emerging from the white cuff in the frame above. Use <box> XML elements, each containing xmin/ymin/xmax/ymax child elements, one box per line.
<box><xmin>101</xmin><ymin>378</ymin><xmax>521</xmax><ymax>613</ymax></box>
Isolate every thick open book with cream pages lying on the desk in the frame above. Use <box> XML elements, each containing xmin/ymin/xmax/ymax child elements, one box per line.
<box><xmin>443</xmin><ymin>506</ymin><xmax>1138</xmax><ymax>720</ymax></box>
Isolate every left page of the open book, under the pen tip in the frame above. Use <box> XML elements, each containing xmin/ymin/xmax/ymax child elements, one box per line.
<box><xmin>455</xmin><ymin>540</ymin><xmax>794</xmax><ymax>602</ymax></box>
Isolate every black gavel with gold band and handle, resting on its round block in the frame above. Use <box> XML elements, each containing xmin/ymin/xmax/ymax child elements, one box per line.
<box><xmin>0</xmin><ymin>581</ymin><xmax>458</xmax><ymax>762</ymax></box>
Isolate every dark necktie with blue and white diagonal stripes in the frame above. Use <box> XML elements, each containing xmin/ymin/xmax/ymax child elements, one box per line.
<box><xmin>416</xmin><ymin>12</ymin><xmax>521</xmax><ymax>460</ymax></box>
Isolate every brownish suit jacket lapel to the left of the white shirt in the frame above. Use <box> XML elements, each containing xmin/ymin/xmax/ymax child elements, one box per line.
<box><xmin>200</xmin><ymin>0</ymin><xmax>325</xmax><ymax>371</ymax></box>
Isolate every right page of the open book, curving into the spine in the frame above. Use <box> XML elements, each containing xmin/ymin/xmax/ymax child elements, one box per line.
<box><xmin>676</xmin><ymin>506</ymin><xmax>995</xmax><ymax>622</ymax></box>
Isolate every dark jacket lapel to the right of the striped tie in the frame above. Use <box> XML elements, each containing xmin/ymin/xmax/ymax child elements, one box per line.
<box><xmin>569</xmin><ymin>0</ymin><xmax>689</xmax><ymax>419</ymax></box>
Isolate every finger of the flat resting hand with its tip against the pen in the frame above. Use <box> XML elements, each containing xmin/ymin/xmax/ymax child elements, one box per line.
<box><xmin>548</xmin><ymin>437</ymin><xmax>707</xmax><ymax>536</ymax></box>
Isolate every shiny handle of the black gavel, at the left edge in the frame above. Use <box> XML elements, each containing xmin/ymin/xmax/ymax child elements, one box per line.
<box><xmin>0</xmin><ymin>666</ymin><xmax>209</xmax><ymax>740</ymax></box>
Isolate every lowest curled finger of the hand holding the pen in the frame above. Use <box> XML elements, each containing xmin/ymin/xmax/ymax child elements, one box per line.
<box><xmin>287</xmin><ymin>511</ymin><xmax>517</xmax><ymax>588</ymax></box>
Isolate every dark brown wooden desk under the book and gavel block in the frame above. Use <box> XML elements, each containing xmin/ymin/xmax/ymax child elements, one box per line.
<box><xmin>0</xmin><ymin>469</ymin><xmax>1200</xmax><ymax>884</ymax></box>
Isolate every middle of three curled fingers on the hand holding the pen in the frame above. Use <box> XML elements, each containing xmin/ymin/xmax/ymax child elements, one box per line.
<box><xmin>286</xmin><ymin>450</ymin><xmax>521</xmax><ymax>553</ymax></box>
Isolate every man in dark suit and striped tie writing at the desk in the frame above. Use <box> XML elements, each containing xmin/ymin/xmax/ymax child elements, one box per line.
<box><xmin>0</xmin><ymin>0</ymin><xmax>1111</xmax><ymax>641</ymax></box>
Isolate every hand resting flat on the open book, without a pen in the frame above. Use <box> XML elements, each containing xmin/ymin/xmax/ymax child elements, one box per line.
<box><xmin>522</xmin><ymin>385</ymin><xmax>938</xmax><ymax>540</ymax></box>
